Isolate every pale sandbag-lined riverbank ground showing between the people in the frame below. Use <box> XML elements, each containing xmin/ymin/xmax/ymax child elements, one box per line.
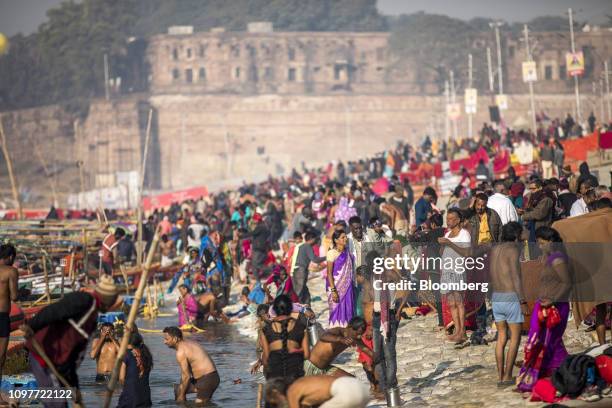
<box><xmin>235</xmin><ymin>274</ymin><xmax>600</xmax><ymax>408</ymax></box>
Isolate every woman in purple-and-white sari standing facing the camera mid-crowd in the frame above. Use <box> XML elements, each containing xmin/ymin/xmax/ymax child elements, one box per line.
<box><xmin>326</xmin><ymin>230</ymin><xmax>355</xmax><ymax>327</ymax></box>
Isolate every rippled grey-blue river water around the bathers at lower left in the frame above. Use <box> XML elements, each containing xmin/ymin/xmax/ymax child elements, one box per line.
<box><xmin>79</xmin><ymin>310</ymin><xmax>257</xmax><ymax>408</ymax></box>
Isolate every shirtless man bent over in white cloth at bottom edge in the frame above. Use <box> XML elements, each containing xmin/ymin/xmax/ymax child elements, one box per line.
<box><xmin>265</xmin><ymin>375</ymin><xmax>370</xmax><ymax>408</ymax></box>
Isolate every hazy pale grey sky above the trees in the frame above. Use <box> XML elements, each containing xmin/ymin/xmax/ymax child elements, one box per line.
<box><xmin>0</xmin><ymin>0</ymin><xmax>612</xmax><ymax>36</ymax></box>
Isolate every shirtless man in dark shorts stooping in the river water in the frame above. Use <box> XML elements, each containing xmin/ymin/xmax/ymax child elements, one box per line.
<box><xmin>164</xmin><ymin>327</ymin><xmax>221</xmax><ymax>404</ymax></box>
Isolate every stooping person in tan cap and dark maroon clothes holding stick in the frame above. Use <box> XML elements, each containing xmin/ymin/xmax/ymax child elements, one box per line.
<box><xmin>21</xmin><ymin>275</ymin><xmax>117</xmax><ymax>408</ymax></box>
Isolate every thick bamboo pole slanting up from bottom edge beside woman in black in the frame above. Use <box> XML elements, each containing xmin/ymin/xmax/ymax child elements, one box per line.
<box><xmin>104</xmin><ymin>231</ymin><xmax>159</xmax><ymax>408</ymax></box>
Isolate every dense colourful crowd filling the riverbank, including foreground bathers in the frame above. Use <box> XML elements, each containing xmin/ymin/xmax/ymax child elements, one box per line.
<box><xmin>4</xmin><ymin>117</ymin><xmax>612</xmax><ymax>407</ymax></box>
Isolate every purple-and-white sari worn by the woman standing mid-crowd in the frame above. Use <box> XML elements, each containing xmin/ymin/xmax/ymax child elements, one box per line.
<box><xmin>325</xmin><ymin>249</ymin><xmax>355</xmax><ymax>327</ymax></box>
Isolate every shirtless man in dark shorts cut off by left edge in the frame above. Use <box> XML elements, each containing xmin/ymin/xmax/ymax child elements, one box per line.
<box><xmin>0</xmin><ymin>244</ymin><xmax>19</xmax><ymax>401</ymax></box>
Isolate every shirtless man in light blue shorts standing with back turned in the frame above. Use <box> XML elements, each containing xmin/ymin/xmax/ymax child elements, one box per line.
<box><xmin>490</xmin><ymin>222</ymin><xmax>529</xmax><ymax>388</ymax></box>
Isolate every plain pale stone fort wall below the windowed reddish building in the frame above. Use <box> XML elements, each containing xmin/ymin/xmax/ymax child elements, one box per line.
<box><xmin>0</xmin><ymin>95</ymin><xmax>600</xmax><ymax>205</ymax></box>
